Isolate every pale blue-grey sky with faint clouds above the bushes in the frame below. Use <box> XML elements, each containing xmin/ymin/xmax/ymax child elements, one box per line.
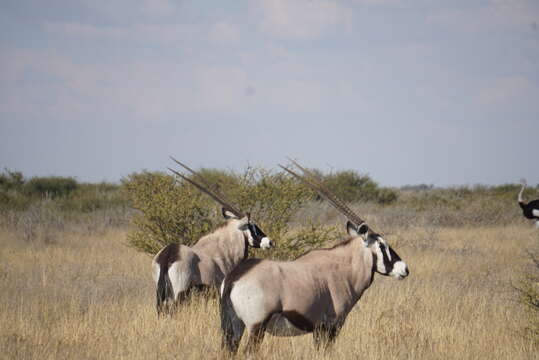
<box><xmin>0</xmin><ymin>0</ymin><xmax>539</xmax><ymax>186</ymax></box>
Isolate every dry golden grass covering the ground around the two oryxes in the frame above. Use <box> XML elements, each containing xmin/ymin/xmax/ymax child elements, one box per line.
<box><xmin>0</xmin><ymin>225</ymin><xmax>539</xmax><ymax>359</ymax></box>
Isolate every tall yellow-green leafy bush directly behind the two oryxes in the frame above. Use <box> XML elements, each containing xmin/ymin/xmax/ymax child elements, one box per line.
<box><xmin>123</xmin><ymin>168</ymin><xmax>313</xmax><ymax>253</ymax></box>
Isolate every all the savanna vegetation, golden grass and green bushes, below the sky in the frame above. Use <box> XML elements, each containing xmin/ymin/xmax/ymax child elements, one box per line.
<box><xmin>0</xmin><ymin>168</ymin><xmax>539</xmax><ymax>359</ymax></box>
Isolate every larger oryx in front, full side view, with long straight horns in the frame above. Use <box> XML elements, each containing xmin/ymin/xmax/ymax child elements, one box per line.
<box><xmin>220</xmin><ymin>164</ymin><xmax>409</xmax><ymax>353</ymax></box>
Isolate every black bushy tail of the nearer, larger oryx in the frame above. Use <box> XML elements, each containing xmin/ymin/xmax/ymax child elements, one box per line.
<box><xmin>219</xmin><ymin>286</ymin><xmax>245</xmax><ymax>354</ymax></box>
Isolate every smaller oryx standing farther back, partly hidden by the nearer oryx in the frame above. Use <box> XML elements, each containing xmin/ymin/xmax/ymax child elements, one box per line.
<box><xmin>152</xmin><ymin>158</ymin><xmax>273</xmax><ymax>314</ymax></box>
